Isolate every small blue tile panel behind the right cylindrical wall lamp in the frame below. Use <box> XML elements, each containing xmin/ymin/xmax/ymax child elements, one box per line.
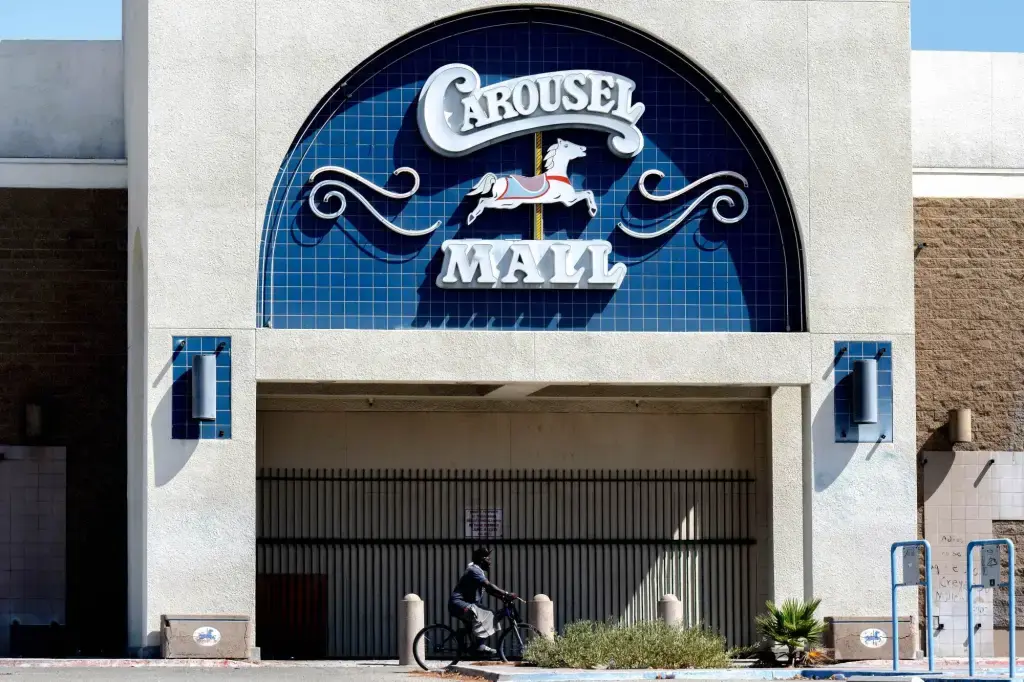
<box><xmin>833</xmin><ymin>341</ymin><xmax>893</xmax><ymax>442</ymax></box>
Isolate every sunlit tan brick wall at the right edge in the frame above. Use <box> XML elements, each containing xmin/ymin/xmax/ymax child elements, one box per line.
<box><xmin>914</xmin><ymin>199</ymin><xmax>1024</xmax><ymax>451</ymax></box>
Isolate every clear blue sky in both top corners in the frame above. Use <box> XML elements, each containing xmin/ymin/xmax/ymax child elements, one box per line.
<box><xmin>0</xmin><ymin>0</ymin><xmax>1024</xmax><ymax>52</ymax></box>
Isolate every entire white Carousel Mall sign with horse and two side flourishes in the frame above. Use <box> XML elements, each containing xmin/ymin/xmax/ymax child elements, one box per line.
<box><xmin>307</xmin><ymin>63</ymin><xmax>748</xmax><ymax>289</ymax></box>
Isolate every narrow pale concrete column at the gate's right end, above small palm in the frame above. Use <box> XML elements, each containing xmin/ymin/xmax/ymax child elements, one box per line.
<box><xmin>769</xmin><ymin>386</ymin><xmax>804</xmax><ymax>601</ymax></box>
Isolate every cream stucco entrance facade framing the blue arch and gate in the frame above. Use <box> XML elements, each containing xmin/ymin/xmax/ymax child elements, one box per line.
<box><xmin>129</xmin><ymin>0</ymin><xmax>916</xmax><ymax>643</ymax></box>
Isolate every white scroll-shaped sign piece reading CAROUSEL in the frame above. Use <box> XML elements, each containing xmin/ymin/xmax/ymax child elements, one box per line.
<box><xmin>417</xmin><ymin>63</ymin><xmax>644</xmax><ymax>158</ymax></box>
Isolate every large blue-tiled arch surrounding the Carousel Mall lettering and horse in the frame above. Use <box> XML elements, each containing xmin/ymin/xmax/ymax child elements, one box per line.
<box><xmin>257</xmin><ymin>7</ymin><xmax>804</xmax><ymax>332</ymax></box>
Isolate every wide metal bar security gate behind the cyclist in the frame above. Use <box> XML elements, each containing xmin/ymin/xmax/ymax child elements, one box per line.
<box><xmin>256</xmin><ymin>469</ymin><xmax>757</xmax><ymax>658</ymax></box>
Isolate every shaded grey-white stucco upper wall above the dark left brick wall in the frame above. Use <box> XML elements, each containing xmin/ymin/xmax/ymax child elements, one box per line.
<box><xmin>0</xmin><ymin>40</ymin><xmax>125</xmax><ymax>159</ymax></box>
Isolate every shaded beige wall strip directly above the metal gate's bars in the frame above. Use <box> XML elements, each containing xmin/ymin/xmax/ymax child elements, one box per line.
<box><xmin>256</xmin><ymin>403</ymin><xmax>757</xmax><ymax>470</ymax></box>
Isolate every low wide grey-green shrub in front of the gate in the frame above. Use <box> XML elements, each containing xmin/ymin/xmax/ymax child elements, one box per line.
<box><xmin>524</xmin><ymin>621</ymin><xmax>729</xmax><ymax>670</ymax></box>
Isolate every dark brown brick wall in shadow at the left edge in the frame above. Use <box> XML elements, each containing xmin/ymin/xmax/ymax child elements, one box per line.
<box><xmin>0</xmin><ymin>189</ymin><xmax>127</xmax><ymax>655</ymax></box>
